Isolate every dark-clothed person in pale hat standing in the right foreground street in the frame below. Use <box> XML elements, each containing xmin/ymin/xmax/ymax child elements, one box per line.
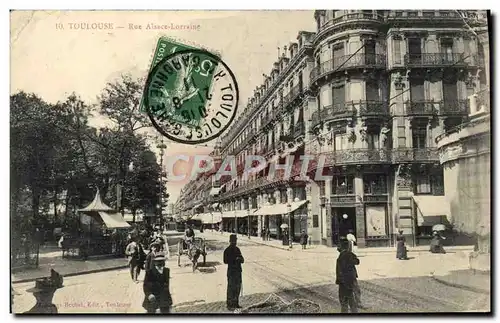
<box><xmin>335</xmin><ymin>239</ymin><xmax>359</xmax><ymax>313</ymax></box>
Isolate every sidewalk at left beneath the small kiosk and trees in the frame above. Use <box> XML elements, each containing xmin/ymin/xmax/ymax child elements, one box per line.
<box><xmin>11</xmin><ymin>246</ymin><xmax>128</xmax><ymax>284</ymax></box>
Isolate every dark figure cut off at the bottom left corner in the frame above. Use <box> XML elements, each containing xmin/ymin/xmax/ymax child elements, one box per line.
<box><xmin>23</xmin><ymin>269</ymin><xmax>63</xmax><ymax>314</ymax></box>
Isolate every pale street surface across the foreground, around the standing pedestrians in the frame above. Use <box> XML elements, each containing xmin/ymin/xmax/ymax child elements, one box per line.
<box><xmin>13</xmin><ymin>233</ymin><xmax>490</xmax><ymax>313</ymax></box>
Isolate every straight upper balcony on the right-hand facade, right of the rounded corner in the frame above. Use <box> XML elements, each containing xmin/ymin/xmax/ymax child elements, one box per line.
<box><xmin>405</xmin><ymin>53</ymin><xmax>468</xmax><ymax>68</ymax></box>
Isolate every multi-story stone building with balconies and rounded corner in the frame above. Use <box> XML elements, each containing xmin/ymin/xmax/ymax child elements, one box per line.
<box><xmin>176</xmin><ymin>10</ymin><xmax>484</xmax><ymax>247</ymax></box>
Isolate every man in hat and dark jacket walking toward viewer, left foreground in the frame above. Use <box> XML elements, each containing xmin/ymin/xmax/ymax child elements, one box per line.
<box><xmin>142</xmin><ymin>252</ymin><xmax>173</xmax><ymax>314</ymax></box>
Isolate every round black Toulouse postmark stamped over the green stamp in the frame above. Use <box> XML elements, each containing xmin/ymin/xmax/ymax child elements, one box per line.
<box><xmin>144</xmin><ymin>49</ymin><xmax>239</xmax><ymax>144</ymax></box>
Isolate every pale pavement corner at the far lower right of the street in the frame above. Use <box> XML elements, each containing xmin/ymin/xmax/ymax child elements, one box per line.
<box><xmin>432</xmin><ymin>269</ymin><xmax>491</xmax><ymax>295</ymax></box>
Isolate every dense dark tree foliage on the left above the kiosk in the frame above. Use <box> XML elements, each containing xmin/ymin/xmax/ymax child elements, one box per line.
<box><xmin>10</xmin><ymin>76</ymin><xmax>166</xmax><ymax>233</ymax></box>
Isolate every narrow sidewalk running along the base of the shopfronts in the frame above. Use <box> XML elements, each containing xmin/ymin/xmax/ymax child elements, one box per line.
<box><xmin>199</xmin><ymin>230</ymin><xmax>474</xmax><ymax>256</ymax></box>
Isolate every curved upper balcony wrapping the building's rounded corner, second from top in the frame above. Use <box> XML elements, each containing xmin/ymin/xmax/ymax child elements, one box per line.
<box><xmin>310</xmin><ymin>53</ymin><xmax>386</xmax><ymax>84</ymax></box>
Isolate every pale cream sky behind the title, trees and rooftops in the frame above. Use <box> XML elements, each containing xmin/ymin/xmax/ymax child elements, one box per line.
<box><xmin>10</xmin><ymin>11</ymin><xmax>316</xmax><ymax>202</ymax></box>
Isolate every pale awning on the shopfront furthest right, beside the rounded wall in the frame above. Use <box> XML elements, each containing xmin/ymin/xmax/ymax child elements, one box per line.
<box><xmin>413</xmin><ymin>195</ymin><xmax>451</xmax><ymax>226</ymax></box>
